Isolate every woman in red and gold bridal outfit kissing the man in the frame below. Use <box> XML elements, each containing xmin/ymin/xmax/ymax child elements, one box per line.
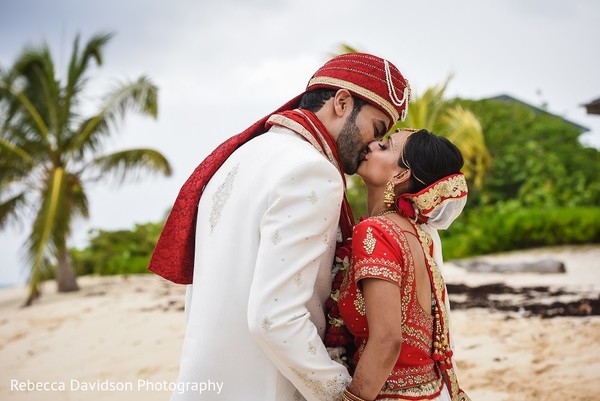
<box><xmin>338</xmin><ymin>130</ymin><xmax>469</xmax><ymax>401</ymax></box>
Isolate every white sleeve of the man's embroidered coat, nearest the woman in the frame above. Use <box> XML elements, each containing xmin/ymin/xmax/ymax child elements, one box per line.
<box><xmin>248</xmin><ymin>159</ymin><xmax>351</xmax><ymax>401</ymax></box>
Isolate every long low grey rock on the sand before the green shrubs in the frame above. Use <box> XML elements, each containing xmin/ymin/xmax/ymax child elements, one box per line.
<box><xmin>452</xmin><ymin>259</ymin><xmax>567</xmax><ymax>274</ymax></box>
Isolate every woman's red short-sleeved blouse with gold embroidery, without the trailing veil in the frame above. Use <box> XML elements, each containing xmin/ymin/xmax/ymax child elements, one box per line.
<box><xmin>339</xmin><ymin>216</ymin><xmax>443</xmax><ymax>399</ymax></box>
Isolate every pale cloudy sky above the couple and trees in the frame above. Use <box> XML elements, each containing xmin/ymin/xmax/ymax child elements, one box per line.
<box><xmin>0</xmin><ymin>0</ymin><xmax>600</xmax><ymax>285</ymax></box>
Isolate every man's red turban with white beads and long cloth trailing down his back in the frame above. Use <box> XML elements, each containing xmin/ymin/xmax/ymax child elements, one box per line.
<box><xmin>148</xmin><ymin>53</ymin><xmax>410</xmax><ymax>284</ymax></box>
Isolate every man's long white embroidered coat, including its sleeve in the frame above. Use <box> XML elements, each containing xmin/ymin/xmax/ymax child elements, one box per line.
<box><xmin>172</xmin><ymin>127</ymin><xmax>350</xmax><ymax>401</ymax></box>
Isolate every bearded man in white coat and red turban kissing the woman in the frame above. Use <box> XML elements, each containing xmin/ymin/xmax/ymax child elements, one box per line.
<box><xmin>149</xmin><ymin>53</ymin><xmax>409</xmax><ymax>401</ymax></box>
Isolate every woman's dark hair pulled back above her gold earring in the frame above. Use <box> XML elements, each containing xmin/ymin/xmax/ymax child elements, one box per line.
<box><xmin>398</xmin><ymin>129</ymin><xmax>464</xmax><ymax>193</ymax></box>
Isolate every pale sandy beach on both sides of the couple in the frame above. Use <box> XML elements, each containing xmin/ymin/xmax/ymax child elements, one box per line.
<box><xmin>0</xmin><ymin>245</ymin><xmax>600</xmax><ymax>401</ymax></box>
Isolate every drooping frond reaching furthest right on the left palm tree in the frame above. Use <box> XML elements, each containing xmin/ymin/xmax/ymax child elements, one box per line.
<box><xmin>87</xmin><ymin>149</ymin><xmax>172</xmax><ymax>183</ymax></box>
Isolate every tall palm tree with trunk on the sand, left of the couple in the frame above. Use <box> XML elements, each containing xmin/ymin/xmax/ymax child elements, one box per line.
<box><xmin>0</xmin><ymin>33</ymin><xmax>171</xmax><ymax>305</ymax></box>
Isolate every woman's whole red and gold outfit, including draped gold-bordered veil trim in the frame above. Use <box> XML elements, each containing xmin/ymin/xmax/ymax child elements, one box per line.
<box><xmin>338</xmin><ymin>175</ymin><xmax>469</xmax><ymax>401</ymax></box>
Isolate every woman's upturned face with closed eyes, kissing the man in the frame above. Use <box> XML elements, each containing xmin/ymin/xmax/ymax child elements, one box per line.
<box><xmin>357</xmin><ymin>131</ymin><xmax>412</xmax><ymax>185</ymax></box>
